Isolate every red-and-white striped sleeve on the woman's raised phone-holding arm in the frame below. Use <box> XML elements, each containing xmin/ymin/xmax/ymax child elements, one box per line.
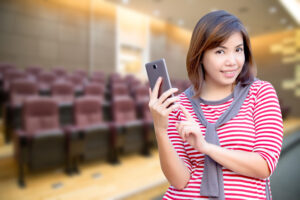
<box><xmin>168</xmin><ymin>110</ymin><xmax>192</xmax><ymax>172</ymax></box>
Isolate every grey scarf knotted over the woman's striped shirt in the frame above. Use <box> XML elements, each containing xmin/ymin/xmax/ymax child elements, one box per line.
<box><xmin>184</xmin><ymin>81</ymin><xmax>270</xmax><ymax>200</ymax></box>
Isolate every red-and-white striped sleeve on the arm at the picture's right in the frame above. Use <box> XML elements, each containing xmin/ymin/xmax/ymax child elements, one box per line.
<box><xmin>253</xmin><ymin>82</ymin><xmax>283</xmax><ymax>174</ymax></box>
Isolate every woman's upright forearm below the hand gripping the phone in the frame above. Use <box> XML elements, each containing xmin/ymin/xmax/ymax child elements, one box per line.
<box><xmin>156</xmin><ymin>127</ymin><xmax>190</xmax><ymax>189</ymax></box>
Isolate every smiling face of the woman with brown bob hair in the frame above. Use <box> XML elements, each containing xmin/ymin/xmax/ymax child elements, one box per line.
<box><xmin>203</xmin><ymin>32</ymin><xmax>245</xmax><ymax>87</ymax></box>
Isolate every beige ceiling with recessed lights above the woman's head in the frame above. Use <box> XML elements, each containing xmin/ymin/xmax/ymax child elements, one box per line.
<box><xmin>106</xmin><ymin>0</ymin><xmax>299</xmax><ymax>36</ymax></box>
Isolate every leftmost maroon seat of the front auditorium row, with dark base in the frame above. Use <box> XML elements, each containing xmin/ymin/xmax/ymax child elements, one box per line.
<box><xmin>14</xmin><ymin>97</ymin><xmax>66</xmax><ymax>187</ymax></box>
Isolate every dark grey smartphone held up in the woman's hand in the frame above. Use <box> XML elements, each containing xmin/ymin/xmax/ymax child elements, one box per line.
<box><xmin>145</xmin><ymin>58</ymin><xmax>174</xmax><ymax>97</ymax></box>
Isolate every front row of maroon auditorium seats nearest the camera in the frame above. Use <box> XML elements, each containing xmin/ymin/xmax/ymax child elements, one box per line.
<box><xmin>14</xmin><ymin>95</ymin><xmax>153</xmax><ymax>186</ymax></box>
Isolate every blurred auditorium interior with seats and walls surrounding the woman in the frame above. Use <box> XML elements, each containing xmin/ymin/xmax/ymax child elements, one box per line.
<box><xmin>0</xmin><ymin>0</ymin><xmax>300</xmax><ymax>200</ymax></box>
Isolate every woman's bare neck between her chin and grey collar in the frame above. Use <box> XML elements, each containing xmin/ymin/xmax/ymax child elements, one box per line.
<box><xmin>200</xmin><ymin>82</ymin><xmax>234</xmax><ymax>101</ymax></box>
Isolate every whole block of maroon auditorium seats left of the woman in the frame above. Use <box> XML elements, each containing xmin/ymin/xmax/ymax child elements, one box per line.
<box><xmin>0</xmin><ymin>62</ymin><xmax>191</xmax><ymax>186</ymax></box>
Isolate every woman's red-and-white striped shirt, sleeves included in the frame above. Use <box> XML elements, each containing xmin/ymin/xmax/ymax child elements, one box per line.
<box><xmin>163</xmin><ymin>80</ymin><xmax>283</xmax><ymax>200</ymax></box>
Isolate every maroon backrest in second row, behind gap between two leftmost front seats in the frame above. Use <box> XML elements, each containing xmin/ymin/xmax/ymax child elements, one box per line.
<box><xmin>51</xmin><ymin>80</ymin><xmax>74</xmax><ymax>103</ymax></box>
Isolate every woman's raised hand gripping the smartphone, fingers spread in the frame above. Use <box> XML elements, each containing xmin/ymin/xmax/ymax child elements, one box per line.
<box><xmin>149</xmin><ymin>77</ymin><xmax>179</xmax><ymax>132</ymax></box>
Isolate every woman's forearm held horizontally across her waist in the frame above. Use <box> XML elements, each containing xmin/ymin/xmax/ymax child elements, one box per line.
<box><xmin>203</xmin><ymin>144</ymin><xmax>270</xmax><ymax>178</ymax></box>
